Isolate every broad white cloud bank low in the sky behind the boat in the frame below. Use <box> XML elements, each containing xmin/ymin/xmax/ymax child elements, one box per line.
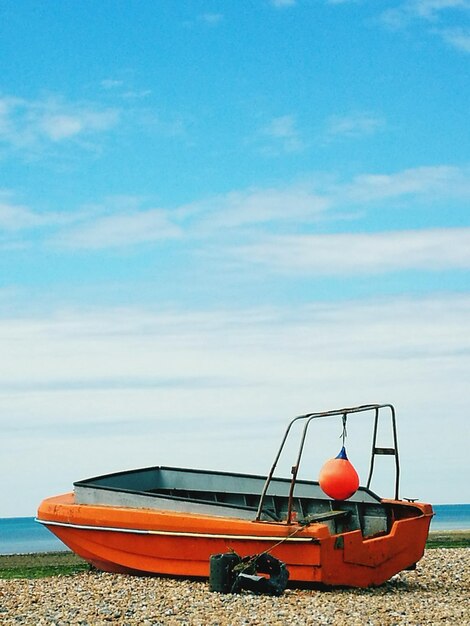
<box><xmin>0</xmin><ymin>294</ymin><xmax>470</xmax><ymax>515</ymax></box>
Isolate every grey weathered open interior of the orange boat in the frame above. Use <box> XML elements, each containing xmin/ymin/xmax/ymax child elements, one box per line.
<box><xmin>74</xmin><ymin>467</ymin><xmax>420</xmax><ymax>537</ymax></box>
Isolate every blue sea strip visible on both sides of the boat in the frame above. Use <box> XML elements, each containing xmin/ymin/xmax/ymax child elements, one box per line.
<box><xmin>0</xmin><ymin>504</ymin><xmax>470</xmax><ymax>554</ymax></box>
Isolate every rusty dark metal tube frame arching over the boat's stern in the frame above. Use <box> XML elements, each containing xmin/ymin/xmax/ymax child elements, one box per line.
<box><xmin>255</xmin><ymin>404</ymin><xmax>400</xmax><ymax>524</ymax></box>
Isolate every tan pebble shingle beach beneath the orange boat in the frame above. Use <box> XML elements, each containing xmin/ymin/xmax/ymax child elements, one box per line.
<box><xmin>0</xmin><ymin>548</ymin><xmax>470</xmax><ymax>626</ymax></box>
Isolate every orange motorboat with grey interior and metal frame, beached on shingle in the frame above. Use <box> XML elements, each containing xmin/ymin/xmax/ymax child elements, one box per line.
<box><xmin>37</xmin><ymin>404</ymin><xmax>433</xmax><ymax>587</ymax></box>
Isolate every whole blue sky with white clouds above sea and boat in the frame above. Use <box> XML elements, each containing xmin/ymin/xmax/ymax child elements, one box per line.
<box><xmin>0</xmin><ymin>0</ymin><xmax>470</xmax><ymax>516</ymax></box>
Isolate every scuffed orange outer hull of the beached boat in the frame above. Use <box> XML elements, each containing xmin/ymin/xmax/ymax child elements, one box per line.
<box><xmin>38</xmin><ymin>493</ymin><xmax>433</xmax><ymax>587</ymax></box>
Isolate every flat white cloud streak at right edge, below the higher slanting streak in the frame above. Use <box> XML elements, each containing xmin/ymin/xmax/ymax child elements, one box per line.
<box><xmin>235</xmin><ymin>228</ymin><xmax>470</xmax><ymax>276</ymax></box>
